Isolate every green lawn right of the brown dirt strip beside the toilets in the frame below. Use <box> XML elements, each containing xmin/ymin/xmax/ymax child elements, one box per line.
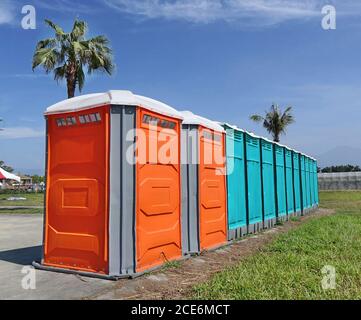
<box><xmin>193</xmin><ymin>192</ymin><xmax>361</xmax><ymax>299</ymax></box>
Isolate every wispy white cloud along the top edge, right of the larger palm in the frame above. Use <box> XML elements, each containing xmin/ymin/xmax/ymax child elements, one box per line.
<box><xmin>103</xmin><ymin>0</ymin><xmax>360</xmax><ymax>26</ymax></box>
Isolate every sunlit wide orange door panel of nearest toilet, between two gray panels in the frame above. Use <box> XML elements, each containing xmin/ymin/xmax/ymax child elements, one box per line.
<box><xmin>136</xmin><ymin>109</ymin><xmax>182</xmax><ymax>272</ymax></box>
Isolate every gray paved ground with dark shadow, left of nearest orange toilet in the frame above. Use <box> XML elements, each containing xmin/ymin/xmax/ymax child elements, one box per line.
<box><xmin>0</xmin><ymin>215</ymin><xmax>115</xmax><ymax>300</ymax></box>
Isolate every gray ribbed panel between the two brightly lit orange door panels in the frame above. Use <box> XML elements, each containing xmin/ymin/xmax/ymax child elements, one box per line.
<box><xmin>181</xmin><ymin>125</ymin><xmax>200</xmax><ymax>255</ymax></box>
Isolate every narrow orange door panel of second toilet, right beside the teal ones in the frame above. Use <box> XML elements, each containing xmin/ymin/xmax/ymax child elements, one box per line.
<box><xmin>199</xmin><ymin>128</ymin><xmax>227</xmax><ymax>250</ymax></box>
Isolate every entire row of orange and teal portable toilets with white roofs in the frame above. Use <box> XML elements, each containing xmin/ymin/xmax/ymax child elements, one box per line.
<box><xmin>33</xmin><ymin>91</ymin><xmax>318</xmax><ymax>279</ymax></box>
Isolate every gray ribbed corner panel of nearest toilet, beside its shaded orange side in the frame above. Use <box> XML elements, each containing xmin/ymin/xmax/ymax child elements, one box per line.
<box><xmin>109</xmin><ymin>106</ymin><xmax>135</xmax><ymax>276</ymax></box>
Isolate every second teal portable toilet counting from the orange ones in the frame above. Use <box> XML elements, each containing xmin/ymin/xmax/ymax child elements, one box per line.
<box><xmin>245</xmin><ymin>132</ymin><xmax>263</xmax><ymax>233</ymax></box>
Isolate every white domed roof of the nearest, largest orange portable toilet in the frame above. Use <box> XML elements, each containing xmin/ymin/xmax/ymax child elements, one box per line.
<box><xmin>45</xmin><ymin>90</ymin><xmax>183</xmax><ymax>119</ymax></box>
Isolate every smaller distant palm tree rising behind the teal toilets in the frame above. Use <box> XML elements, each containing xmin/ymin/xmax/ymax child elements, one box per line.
<box><xmin>250</xmin><ymin>104</ymin><xmax>295</xmax><ymax>142</ymax></box>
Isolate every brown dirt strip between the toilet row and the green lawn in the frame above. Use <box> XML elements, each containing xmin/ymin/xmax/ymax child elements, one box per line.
<box><xmin>86</xmin><ymin>209</ymin><xmax>334</xmax><ymax>300</ymax></box>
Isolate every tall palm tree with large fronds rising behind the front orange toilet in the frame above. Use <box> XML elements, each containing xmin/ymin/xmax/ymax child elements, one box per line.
<box><xmin>33</xmin><ymin>20</ymin><xmax>114</xmax><ymax>98</ymax></box>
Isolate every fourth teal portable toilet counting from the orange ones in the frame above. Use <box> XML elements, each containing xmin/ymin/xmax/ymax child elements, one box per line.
<box><xmin>274</xmin><ymin>143</ymin><xmax>287</xmax><ymax>220</ymax></box>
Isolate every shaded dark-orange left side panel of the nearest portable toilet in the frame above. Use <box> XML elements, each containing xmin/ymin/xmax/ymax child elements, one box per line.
<box><xmin>44</xmin><ymin>107</ymin><xmax>109</xmax><ymax>274</ymax></box>
